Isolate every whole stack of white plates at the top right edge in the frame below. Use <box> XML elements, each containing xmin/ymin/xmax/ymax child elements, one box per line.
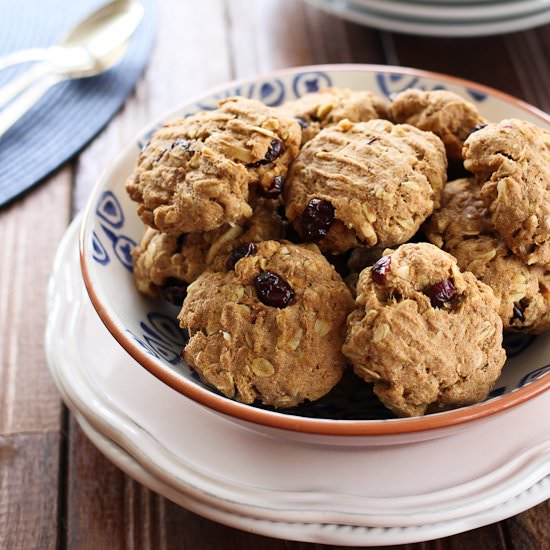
<box><xmin>306</xmin><ymin>0</ymin><xmax>550</xmax><ymax>36</ymax></box>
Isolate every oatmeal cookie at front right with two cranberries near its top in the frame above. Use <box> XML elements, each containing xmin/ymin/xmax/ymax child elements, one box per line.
<box><xmin>342</xmin><ymin>243</ymin><xmax>505</xmax><ymax>416</ymax></box>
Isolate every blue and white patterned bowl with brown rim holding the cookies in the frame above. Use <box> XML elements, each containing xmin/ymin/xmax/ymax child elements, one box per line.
<box><xmin>80</xmin><ymin>65</ymin><xmax>550</xmax><ymax>436</ymax></box>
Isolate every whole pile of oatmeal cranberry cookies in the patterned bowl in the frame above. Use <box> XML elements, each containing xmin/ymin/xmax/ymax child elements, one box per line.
<box><xmin>126</xmin><ymin>88</ymin><xmax>550</xmax><ymax>416</ymax></box>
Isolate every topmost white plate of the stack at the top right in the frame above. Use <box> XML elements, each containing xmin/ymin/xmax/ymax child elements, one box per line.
<box><xmin>350</xmin><ymin>0</ymin><xmax>550</xmax><ymax>23</ymax></box>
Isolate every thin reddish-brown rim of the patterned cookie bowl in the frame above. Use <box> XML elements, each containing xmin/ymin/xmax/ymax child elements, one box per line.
<box><xmin>79</xmin><ymin>63</ymin><xmax>550</xmax><ymax>437</ymax></box>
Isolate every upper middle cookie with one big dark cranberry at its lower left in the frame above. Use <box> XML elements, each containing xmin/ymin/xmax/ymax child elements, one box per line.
<box><xmin>283</xmin><ymin>120</ymin><xmax>447</xmax><ymax>253</ymax></box>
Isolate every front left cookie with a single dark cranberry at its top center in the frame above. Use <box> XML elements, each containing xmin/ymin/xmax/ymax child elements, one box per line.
<box><xmin>179</xmin><ymin>241</ymin><xmax>353</xmax><ymax>407</ymax></box>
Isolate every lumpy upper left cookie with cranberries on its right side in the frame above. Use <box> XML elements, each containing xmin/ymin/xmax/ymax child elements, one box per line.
<box><xmin>126</xmin><ymin>98</ymin><xmax>301</xmax><ymax>233</ymax></box>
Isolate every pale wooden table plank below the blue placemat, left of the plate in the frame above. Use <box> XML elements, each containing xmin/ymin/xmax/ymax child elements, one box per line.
<box><xmin>0</xmin><ymin>167</ymin><xmax>71</xmax><ymax>434</ymax></box>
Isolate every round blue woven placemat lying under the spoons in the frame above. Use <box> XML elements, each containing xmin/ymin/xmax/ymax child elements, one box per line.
<box><xmin>0</xmin><ymin>0</ymin><xmax>156</xmax><ymax>205</ymax></box>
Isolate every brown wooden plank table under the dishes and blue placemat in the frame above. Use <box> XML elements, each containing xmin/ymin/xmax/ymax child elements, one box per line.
<box><xmin>0</xmin><ymin>0</ymin><xmax>550</xmax><ymax>550</ymax></box>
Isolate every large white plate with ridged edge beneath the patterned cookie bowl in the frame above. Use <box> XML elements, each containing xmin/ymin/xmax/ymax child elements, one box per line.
<box><xmin>46</xmin><ymin>217</ymin><xmax>550</xmax><ymax>545</ymax></box>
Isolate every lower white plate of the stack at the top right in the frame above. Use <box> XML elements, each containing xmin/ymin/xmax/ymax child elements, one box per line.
<box><xmin>306</xmin><ymin>0</ymin><xmax>550</xmax><ymax>37</ymax></box>
